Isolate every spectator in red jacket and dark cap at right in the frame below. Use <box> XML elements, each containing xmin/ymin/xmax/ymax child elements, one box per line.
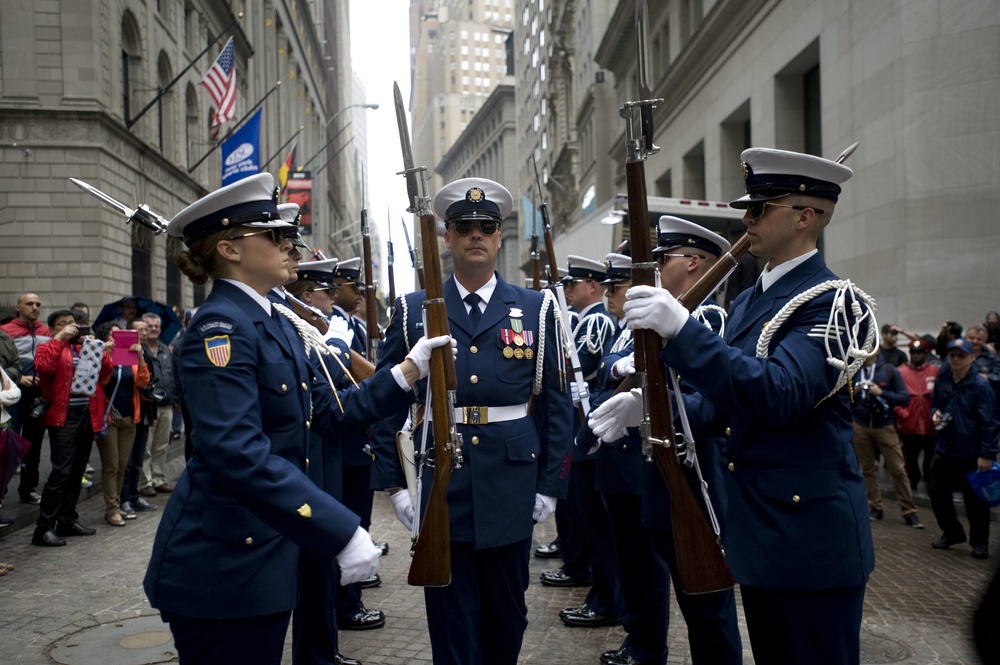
<box><xmin>896</xmin><ymin>337</ymin><xmax>938</xmax><ymax>490</ymax></box>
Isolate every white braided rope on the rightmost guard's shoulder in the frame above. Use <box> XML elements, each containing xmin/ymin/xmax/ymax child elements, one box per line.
<box><xmin>757</xmin><ymin>279</ymin><xmax>878</xmax><ymax>406</ymax></box>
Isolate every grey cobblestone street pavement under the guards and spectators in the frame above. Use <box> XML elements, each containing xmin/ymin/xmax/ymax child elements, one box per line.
<box><xmin>0</xmin><ymin>446</ymin><xmax>1000</xmax><ymax>665</ymax></box>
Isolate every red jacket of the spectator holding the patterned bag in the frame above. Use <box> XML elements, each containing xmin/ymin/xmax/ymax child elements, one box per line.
<box><xmin>35</xmin><ymin>339</ymin><xmax>111</xmax><ymax>432</ymax></box>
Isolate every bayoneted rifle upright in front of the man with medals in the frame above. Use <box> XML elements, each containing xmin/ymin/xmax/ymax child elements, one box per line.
<box><xmin>393</xmin><ymin>83</ymin><xmax>462</xmax><ymax>586</ymax></box>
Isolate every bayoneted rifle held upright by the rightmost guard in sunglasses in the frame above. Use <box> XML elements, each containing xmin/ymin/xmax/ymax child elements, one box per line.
<box><xmin>619</xmin><ymin>0</ymin><xmax>734</xmax><ymax>594</ymax></box>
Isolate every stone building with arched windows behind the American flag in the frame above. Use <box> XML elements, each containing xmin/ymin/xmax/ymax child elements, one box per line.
<box><xmin>0</xmin><ymin>0</ymin><xmax>350</xmax><ymax>311</ymax></box>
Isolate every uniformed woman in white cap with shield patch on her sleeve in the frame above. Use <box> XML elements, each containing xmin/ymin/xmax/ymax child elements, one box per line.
<box><xmin>143</xmin><ymin>173</ymin><xmax>449</xmax><ymax>665</ymax></box>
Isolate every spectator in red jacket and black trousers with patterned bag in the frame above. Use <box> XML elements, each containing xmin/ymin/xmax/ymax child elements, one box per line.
<box><xmin>31</xmin><ymin>309</ymin><xmax>111</xmax><ymax>547</ymax></box>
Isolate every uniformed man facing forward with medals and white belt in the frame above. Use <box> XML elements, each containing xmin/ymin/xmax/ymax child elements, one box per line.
<box><xmin>372</xmin><ymin>178</ymin><xmax>573</xmax><ymax>665</ymax></box>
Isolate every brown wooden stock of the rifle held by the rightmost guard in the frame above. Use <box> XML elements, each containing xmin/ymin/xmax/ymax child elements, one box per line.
<box><xmin>625</xmin><ymin>161</ymin><xmax>734</xmax><ymax>594</ymax></box>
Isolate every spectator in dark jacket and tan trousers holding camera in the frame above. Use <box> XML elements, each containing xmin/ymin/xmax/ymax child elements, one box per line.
<box><xmin>851</xmin><ymin>348</ymin><xmax>924</xmax><ymax>529</ymax></box>
